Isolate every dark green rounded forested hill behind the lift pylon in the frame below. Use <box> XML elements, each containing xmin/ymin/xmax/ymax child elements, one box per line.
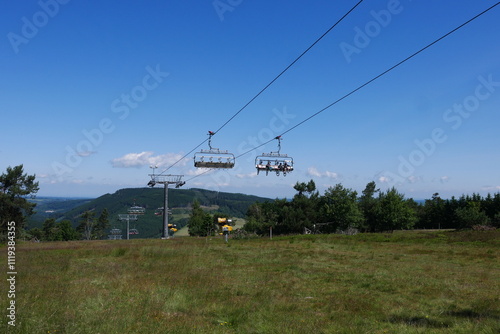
<box><xmin>29</xmin><ymin>187</ymin><xmax>271</xmax><ymax>232</ymax></box>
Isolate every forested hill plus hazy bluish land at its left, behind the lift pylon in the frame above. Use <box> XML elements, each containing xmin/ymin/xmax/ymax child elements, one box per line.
<box><xmin>28</xmin><ymin>188</ymin><xmax>272</xmax><ymax>238</ymax></box>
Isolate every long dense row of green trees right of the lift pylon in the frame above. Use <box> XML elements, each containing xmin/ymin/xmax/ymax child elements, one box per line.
<box><xmin>243</xmin><ymin>180</ymin><xmax>500</xmax><ymax>235</ymax></box>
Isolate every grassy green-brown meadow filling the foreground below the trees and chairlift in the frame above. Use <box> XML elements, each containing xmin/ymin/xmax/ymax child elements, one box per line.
<box><xmin>0</xmin><ymin>231</ymin><xmax>500</xmax><ymax>334</ymax></box>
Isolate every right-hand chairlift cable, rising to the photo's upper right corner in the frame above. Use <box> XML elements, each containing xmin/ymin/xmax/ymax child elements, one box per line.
<box><xmin>185</xmin><ymin>1</ymin><xmax>500</xmax><ymax>180</ymax></box>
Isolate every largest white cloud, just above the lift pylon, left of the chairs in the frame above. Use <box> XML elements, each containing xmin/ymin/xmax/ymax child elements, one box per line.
<box><xmin>111</xmin><ymin>151</ymin><xmax>187</xmax><ymax>168</ymax></box>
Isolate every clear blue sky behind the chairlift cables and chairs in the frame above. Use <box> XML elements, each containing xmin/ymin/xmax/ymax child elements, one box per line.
<box><xmin>0</xmin><ymin>0</ymin><xmax>500</xmax><ymax>199</ymax></box>
